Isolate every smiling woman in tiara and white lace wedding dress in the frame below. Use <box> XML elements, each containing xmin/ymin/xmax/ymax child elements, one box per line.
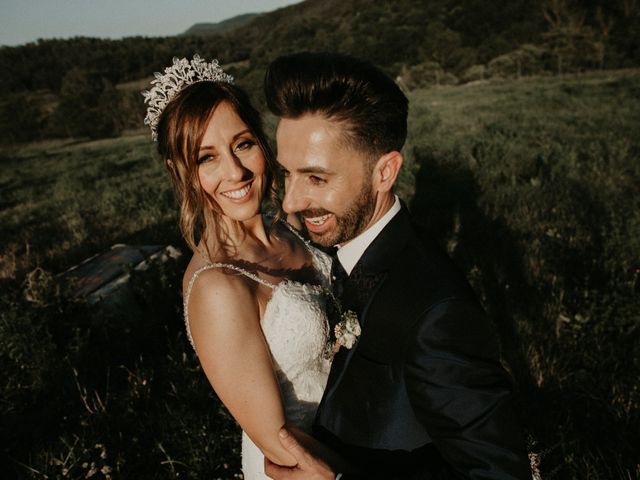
<box><xmin>143</xmin><ymin>55</ymin><xmax>340</xmax><ymax>479</ymax></box>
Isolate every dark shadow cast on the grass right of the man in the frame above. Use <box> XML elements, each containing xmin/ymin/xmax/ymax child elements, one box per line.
<box><xmin>410</xmin><ymin>150</ymin><xmax>637</xmax><ymax>478</ymax></box>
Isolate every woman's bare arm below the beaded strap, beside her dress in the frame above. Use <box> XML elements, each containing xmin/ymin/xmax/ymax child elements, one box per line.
<box><xmin>188</xmin><ymin>269</ymin><xmax>295</xmax><ymax>465</ymax></box>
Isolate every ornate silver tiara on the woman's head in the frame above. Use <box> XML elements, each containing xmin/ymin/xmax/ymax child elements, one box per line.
<box><xmin>142</xmin><ymin>54</ymin><xmax>233</xmax><ymax>140</ymax></box>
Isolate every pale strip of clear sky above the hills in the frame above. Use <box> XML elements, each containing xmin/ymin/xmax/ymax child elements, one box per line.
<box><xmin>0</xmin><ymin>0</ymin><xmax>301</xmax><ymax>46</ymax></box>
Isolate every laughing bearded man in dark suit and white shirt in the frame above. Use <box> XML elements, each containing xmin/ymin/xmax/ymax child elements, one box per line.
<box><xmin>265</xmin><ymin>53</ymin><xmax>531</xmax><ymax>480</ymax></box>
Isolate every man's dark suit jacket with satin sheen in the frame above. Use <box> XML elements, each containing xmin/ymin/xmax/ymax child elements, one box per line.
<box><xmin>314</xmin><ymin>206</ymin><xmax>531</xmax><ymax>479</ymax></box>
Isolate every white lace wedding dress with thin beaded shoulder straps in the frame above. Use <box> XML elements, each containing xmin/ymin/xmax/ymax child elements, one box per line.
<box><xmin>184</xmin><ymin>232</ymin><xmax>331</xmax><ymax>480</ymax></box>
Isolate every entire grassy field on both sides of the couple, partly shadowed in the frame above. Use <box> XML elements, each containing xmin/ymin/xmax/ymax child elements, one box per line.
<box><xmin>0</xmin><ymin>71</ymin><xmax>640</xmax><ymax>479</ymax></box>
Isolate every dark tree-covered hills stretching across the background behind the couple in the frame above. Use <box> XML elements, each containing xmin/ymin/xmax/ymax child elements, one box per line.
<box><xmin>0</xmin><ymin>0</ymin><xmax>640</xmax><ymax>143</ymax></box>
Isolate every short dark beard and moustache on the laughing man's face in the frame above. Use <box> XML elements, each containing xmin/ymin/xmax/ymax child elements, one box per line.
<box><xmin>299</xmin><ymin>183</ymin><xmax>376</xmax><ymax>247</ymax></box>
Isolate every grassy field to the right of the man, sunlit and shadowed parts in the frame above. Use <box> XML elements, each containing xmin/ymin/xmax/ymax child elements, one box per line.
<box><xmin>410</xmin><ymin>72</ymin><xmax>640</xmax><ymax>479</ymax></box>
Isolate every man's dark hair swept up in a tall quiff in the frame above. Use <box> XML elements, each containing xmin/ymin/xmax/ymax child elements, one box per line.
<box><xmin>264</xmin><ymin>52</ymin><xmax>408</xmax><ymax>158</ymax></box>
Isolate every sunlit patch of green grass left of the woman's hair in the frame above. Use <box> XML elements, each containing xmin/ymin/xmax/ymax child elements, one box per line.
<box><xmin>0</xmin><ymin>135</ymin><xmax>176</xmax><ymax>278</ymax></box>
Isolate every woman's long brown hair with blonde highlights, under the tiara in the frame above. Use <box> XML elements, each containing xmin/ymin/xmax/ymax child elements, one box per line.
<box><xmin>158</xmin><ymin>81</ymin><xmax>280</xmax><ymax>260</ymax></box>
